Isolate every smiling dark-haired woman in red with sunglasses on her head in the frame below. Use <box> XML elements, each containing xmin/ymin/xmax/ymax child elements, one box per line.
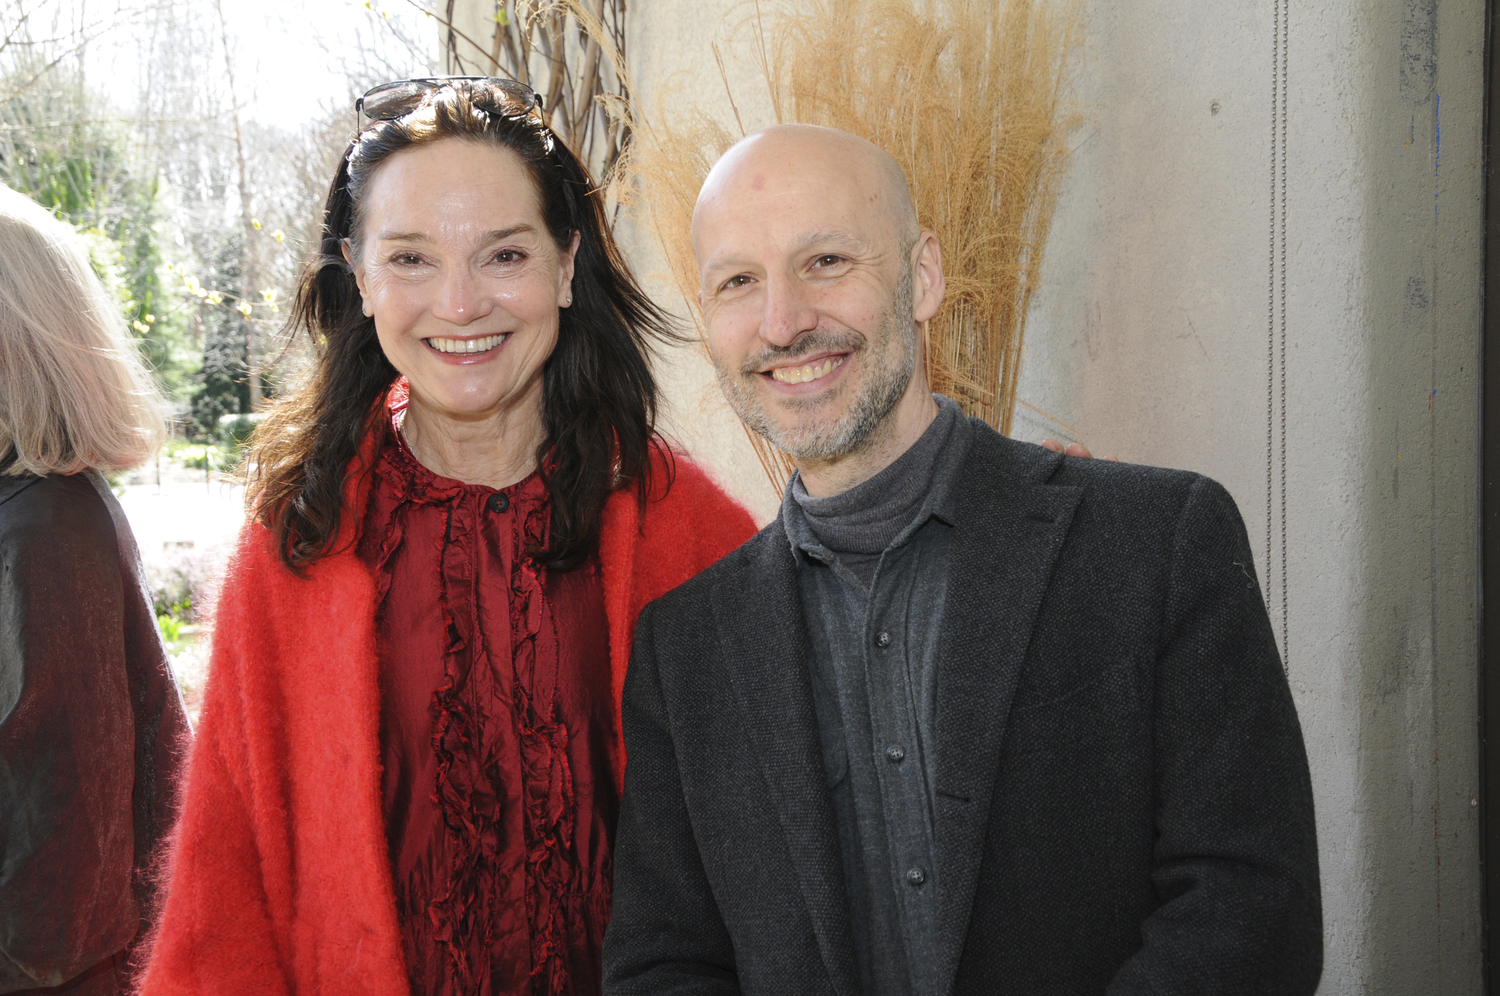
<box><xmin>144</xmin><ymin>80</ymin><xmax>753</xmax><ymax>996</ymax></box>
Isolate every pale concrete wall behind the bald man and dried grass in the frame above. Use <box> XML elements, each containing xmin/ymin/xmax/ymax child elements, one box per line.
<box><xmin>462</xmin><ymin>0</ymin><xmax>1485</xmax><ymax>996</ymax></box>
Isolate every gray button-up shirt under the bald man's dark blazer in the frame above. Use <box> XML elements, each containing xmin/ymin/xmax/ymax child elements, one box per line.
<box><xmin>782</xmin><ymin>396</ymin><xmax>972</xmax><ymax>996</ymax></box>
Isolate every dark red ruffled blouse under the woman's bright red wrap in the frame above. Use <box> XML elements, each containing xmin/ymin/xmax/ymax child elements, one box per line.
<box><xmin>360</xmin><ymin>399</ymin><xmax>618</xmax><ymax>996</ymax></box>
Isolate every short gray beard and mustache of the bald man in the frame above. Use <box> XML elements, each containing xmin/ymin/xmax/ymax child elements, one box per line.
<box><xmin>714</xmin><ymin>270</ymin><xmax>917</xmax><ymax>462</ymax></box>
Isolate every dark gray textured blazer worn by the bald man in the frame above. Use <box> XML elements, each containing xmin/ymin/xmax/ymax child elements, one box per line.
<box><xmin>605</xmin><ymin>423</ymin><xmax>1323</xmax><ymax>996</ymax></box>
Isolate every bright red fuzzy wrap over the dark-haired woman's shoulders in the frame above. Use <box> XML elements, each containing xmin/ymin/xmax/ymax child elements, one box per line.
<box><xmin>143</xmin><ymin>444</ymin><xmax>755</xmax><ymax>996</ymax></box>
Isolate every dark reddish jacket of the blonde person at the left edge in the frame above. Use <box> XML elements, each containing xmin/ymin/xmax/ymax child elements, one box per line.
<box><xmin>0</xmin><ymin>471</ymin><xmax>188</xmax><ymax>996</ymax></box>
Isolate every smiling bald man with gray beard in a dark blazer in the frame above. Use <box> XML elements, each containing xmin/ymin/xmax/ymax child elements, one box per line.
<box><xmin>605</xmin><ymin>126</ymin><xmax>1322</xmax><ymax>996</ymax></box>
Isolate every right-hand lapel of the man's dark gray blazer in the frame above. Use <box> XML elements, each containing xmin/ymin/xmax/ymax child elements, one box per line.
<box><xmin>935</xmin><ymin>428</ymin><xmax>1082</xmax><ymax>993</ymax></box>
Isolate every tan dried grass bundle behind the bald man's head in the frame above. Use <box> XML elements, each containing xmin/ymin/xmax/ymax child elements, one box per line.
<box><xmin>623</xmin><ymin>0</ymin><xmax>1079</xmax><ymax>483</ymax></box>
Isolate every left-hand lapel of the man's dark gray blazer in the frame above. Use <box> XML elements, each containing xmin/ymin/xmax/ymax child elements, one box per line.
<box><xmin>714</xmin><ymin>534</ymin><xmax>860</xmax><ymax>996</ymax></box>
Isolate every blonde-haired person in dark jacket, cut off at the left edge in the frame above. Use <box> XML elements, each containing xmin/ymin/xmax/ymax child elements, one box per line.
<box><xmin>0</xmin><ymin>188</ymin><xmax>188</xmax><ymax>995</ymax></box>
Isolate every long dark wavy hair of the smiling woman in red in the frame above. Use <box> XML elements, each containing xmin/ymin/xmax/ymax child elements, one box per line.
<box><xmin>248</xmin><ymin>86</ymin><xmax>681</xmax><ymax>573</ymax></box>
